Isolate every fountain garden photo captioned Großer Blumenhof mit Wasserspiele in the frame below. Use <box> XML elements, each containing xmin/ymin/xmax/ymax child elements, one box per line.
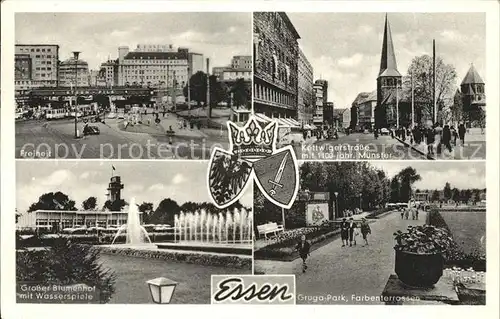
<box><xmin>16</xmin><ymin>160</ymin><xmax>253</xmax><ymax>304</ymax></box>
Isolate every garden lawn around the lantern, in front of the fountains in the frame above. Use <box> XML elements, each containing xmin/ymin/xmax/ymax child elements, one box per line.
<box><xmin>99</xmin><ymin>254</ymin><xmax>251</xmax><ymax>304</ymax></box>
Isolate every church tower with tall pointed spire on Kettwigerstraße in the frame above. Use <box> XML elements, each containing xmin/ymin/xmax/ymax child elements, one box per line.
<box><xmin>375</xmin><ymin>14</ymin><xmax>401</xmax><ymax>128</ymax></box>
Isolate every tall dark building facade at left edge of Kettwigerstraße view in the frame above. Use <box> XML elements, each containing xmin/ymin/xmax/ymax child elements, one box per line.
<box><xmin>253</xmin><ymin>12</ymin><xmax>300</xmax><ymax>119</ymax></box>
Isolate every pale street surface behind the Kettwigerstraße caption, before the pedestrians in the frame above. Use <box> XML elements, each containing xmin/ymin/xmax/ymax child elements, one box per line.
<box><xmin>295</xmin><ymin>133</ymin><xmax>425</xmax><ymax>160</ymax></box>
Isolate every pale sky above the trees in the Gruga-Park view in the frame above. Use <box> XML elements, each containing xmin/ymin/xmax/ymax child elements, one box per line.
<box><xmin>369</xmin><ymin>161</ymin><xmax>486</xmax><ymax>189</ymax></box>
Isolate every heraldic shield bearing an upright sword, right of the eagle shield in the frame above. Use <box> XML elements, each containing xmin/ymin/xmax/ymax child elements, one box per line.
<box><xmin>254</xmin><ymin>146</ymin><xmax>299</xmax><ymax>209</ymax></box>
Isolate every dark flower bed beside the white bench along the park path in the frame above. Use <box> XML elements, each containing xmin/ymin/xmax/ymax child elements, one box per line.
<box><xmin>254</xmin><ymin>226</ymin><xmax>340</xmax><ymax>261</ymax></box>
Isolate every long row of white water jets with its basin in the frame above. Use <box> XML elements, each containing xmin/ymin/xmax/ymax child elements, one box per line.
<box><xmin>156</xmin><ymin>209</ymin><xmax>253</xmax><ymax>255</ymax></box>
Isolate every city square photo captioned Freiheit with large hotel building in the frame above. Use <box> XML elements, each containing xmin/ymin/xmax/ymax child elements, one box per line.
<box><xmin>15</xmin><ymin>12</ymin><xmax>252</xmax><ymax>160</ymax></box>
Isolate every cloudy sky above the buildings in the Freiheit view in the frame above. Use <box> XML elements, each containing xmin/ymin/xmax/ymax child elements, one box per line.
<box><xmin>15</xmin><ymin>12</ymin><xmax>252</xmax><ymax>69</ymax></box>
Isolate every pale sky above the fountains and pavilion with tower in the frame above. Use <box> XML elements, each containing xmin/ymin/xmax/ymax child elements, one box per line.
<box><xmin>16</xmin><ymin>161</ymin><xmax>253</xmax><ymax>212</ymax></box>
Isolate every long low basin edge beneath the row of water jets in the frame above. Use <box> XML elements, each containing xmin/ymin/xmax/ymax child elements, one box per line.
<box><xmin>156</xmin><ymin>241</ymin><xmax>253</xmax><ymax>256</ymax></box>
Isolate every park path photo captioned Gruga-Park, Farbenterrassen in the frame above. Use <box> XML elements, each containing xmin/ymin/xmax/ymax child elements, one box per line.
<box><xmin>254</xmin><ymin>161</ymin><xmax>486</xmax><ymax>305</ymax></box>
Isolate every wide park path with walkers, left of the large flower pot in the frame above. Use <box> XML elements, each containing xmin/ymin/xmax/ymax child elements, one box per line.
<box><xmin>255</xmin><ymin>212</ymin><xmax>425</xmax><ymax>304</ymax></box>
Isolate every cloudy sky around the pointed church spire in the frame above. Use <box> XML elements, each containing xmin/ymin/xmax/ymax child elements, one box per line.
<box><xmin>287</xmin><ymin>12</ymin><xmax>486</xmax><ymax>108</ymax></box>
